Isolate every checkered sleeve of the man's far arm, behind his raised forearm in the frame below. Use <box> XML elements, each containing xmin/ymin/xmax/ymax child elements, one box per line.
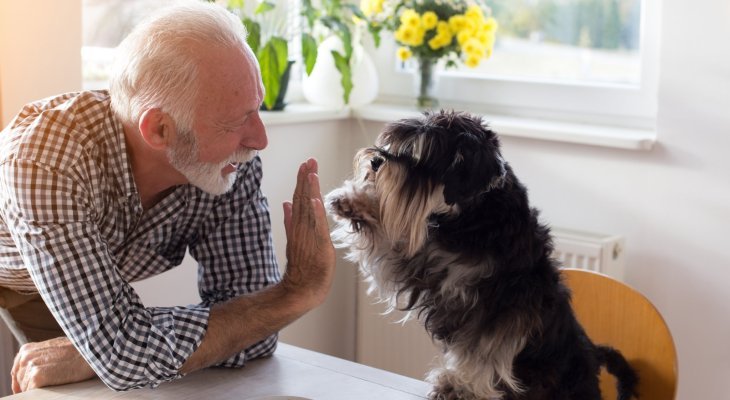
<box><xmin>190</xmin><ymin>157</ymin><xmax>281</xmax><ymax>367</ymax></box>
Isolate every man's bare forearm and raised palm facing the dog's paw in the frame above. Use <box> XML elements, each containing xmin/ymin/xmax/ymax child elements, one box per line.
<box><xmin>180</xmin><ymin>159</ymin><xmax>335</xmax><ymax>373</ymax></box>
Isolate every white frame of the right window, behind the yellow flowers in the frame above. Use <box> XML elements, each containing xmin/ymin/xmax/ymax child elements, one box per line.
<box><xmin>368</xmin><ymin>0</ymin><xmax>661</xmax><ymax>129</ymax></box>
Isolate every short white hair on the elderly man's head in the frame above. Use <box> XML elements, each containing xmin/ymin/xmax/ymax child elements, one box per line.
<box><xmin>110</xmin><ymin>0</ymin><xmax>256</xmax><ymax>131</ymax></box>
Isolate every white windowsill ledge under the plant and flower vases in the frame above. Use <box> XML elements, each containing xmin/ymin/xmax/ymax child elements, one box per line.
<box><xmin>262</xmin><ymin>103</ymin><xmax>656</xmax><ymax>151</ymax></box>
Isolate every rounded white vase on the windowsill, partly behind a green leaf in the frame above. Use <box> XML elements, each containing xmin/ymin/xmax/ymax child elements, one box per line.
<box><xmin>302</xmin><ymin>36</ymin><xmax>378</xmax><ymax>107</ymax></box>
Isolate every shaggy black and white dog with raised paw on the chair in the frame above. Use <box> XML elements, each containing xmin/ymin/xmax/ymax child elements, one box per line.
<box><xmin>326</xmin><ymin>111</ymin><xmax>638</xmax><ymax>400</ymax></box>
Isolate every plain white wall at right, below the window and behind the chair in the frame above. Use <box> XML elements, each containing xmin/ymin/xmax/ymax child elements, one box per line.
<box><xmin>367</xmin><ymin>0</ymin><xmax>730</xmax><ymax>400</ymax></box>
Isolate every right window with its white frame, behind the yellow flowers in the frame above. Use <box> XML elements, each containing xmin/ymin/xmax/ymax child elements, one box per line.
<box><xmin>375</xmin><ymin>0</ymin><xmax>660</xmax><ymax>128</ymax></box>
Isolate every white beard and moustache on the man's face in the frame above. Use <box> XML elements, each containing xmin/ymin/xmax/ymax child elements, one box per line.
<box><xmin>167</xmin><ymin>132</ymin><xmax>258</xmax><ymax>196</ymax></box>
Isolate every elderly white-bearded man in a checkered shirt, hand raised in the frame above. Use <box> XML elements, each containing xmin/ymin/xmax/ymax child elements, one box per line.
<box><xmin>0</xmin><ymin>2</ymin><xmax>335</xmax><ymax>392</ymax></box>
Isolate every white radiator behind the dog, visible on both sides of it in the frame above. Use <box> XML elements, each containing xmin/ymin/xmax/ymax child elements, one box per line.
<box><xmin>355</xmin><ymin>228</ymin><xmax>624</xmax><ymax>379</ymax></box>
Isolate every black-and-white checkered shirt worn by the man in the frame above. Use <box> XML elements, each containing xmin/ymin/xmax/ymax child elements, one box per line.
<box><xmin>0</xmin><ymin>91</ymin><xmax>280</xmax><ymax>390</ymax></box>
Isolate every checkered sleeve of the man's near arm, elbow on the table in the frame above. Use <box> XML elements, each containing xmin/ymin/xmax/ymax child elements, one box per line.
<box><xmin>0</xmin><ymin>160</ymin><xmax>209</xmax><ymax>390</ymax></box>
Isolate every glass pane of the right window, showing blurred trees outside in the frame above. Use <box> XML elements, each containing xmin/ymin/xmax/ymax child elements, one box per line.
<box><xmin>466</xmin><ymin>0</ymin><xmax>641</xmax><ymax>87</ymax></box>
